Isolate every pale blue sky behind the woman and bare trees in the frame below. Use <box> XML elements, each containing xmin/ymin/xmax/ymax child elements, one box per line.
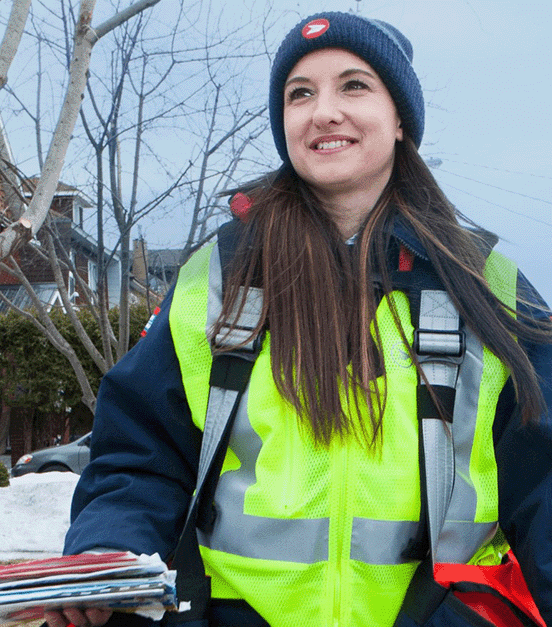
<box><xmin>0</xmin><ymin>0</ymin><xmax>552</xmax><ymax>304</ymax></box>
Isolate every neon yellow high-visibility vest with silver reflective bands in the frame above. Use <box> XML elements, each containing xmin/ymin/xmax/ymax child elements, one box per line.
<box><xmin>170</xmin><ymin>245</ymin><xmax>517</xmax><ymax>627</ymax></box>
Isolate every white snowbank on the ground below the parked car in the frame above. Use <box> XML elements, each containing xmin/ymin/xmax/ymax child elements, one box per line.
<box><xmin>0</xmin><ymin>472</ymin><xmax>79</xmax><ymax>561</ymax></box>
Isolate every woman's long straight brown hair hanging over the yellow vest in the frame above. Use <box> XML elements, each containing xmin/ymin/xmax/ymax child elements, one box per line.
<box><xmin>214</xmin><ymin>137</ymin><xmax>552</xmax><ymax>445</ymax></box>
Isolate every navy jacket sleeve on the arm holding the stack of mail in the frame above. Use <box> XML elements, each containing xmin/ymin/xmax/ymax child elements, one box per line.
<box><xmin>64</xmin><ymin>293</ymin><xmax>201</xmax><ymax>559</ymax></box>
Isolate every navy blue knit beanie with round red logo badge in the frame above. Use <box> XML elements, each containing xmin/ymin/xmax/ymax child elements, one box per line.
<box><xmin>268</xmin><ymin>12</ymin><xmax>424</xmax><ymax>164</ymax></box>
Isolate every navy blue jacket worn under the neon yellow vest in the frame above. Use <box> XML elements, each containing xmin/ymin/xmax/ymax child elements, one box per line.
<box><xmin>64</xmin><ymin>220</ymin><xmax>552</xmax><ymax>626</ymax></box>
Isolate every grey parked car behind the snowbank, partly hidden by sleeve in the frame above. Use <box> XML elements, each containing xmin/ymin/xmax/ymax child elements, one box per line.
<box><xmin>11</xmin><ymin>433</ymin><xmax>90</xmax><ymax>477</ymax></box>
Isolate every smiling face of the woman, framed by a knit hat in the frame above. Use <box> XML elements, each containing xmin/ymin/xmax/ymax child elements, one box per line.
<box><xmin>284</xmin><ymin>48</ymin><xmax>403</xmax><ymax>197</ymax></box>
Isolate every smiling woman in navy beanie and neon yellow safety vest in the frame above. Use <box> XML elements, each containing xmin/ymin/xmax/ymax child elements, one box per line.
<box><xmin>47</xmin><ymin>13</ymin><xmax>552</xmax><ymax>627</ymax></box>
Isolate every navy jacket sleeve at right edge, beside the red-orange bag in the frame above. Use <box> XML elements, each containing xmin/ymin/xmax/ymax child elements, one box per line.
<box><xmin>495</xmin><ymin>274</ymin><xmax>552</xmax><ymax>625</ymax></box>
